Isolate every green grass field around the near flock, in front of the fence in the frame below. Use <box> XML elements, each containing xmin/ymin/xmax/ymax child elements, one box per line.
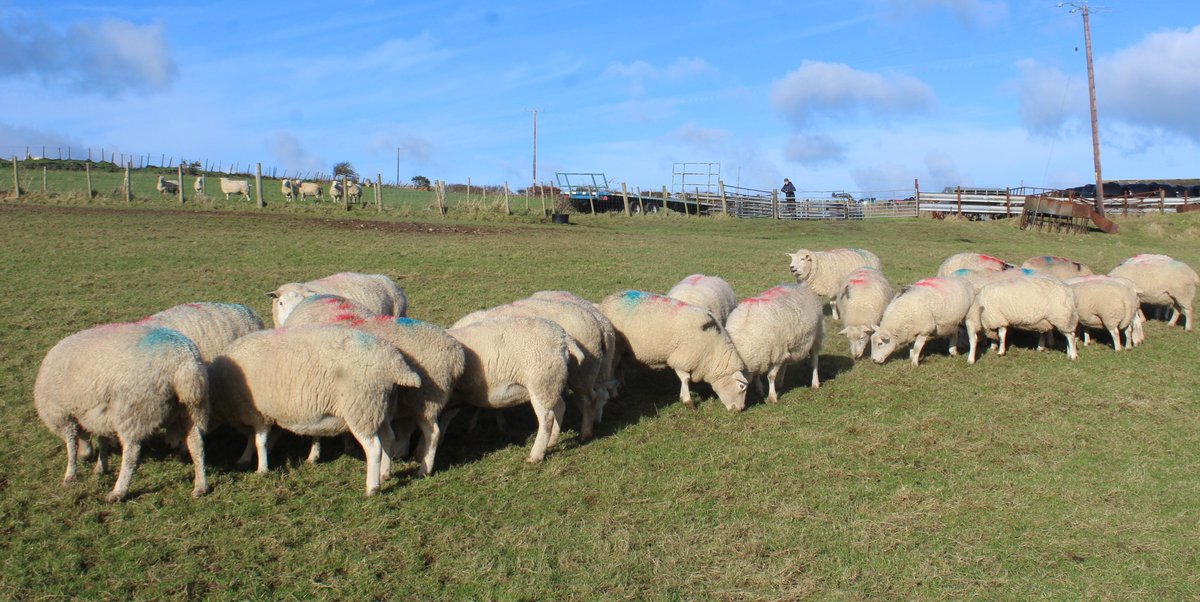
<box><xmin>0</xmin><ymin>198</ymin><xmax>1200</xmax><ymax>600</ymax></box>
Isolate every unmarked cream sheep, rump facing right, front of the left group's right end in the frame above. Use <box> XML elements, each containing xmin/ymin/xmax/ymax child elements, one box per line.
<box><xmin>442</xmin><ymin>318</ymin><xmax>583</xmax><ymax>464</ymax></box>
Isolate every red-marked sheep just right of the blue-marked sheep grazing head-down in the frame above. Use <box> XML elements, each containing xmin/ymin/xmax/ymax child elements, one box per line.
<box><xmin>726</xmin><ymin>284</ymin><xmax>824</xmax><ymax>403</ymax></box>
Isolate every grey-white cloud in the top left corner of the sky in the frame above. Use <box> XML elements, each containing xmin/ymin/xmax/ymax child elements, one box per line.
<box><xmin>0</xmin><ymin>19</ymin><xmax>179</xmax><ymax>96</ymax></box>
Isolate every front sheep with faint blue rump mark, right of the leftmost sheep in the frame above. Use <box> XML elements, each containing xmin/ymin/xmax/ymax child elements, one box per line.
<box><xmin>209</xmin><ymin>324</ymin><xmax>421</xmax><ymax>495</ymax></box>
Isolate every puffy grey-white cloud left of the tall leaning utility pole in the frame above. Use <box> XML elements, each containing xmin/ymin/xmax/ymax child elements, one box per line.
<box><xmin>770</xmin><ymin>60</ymin><xmax>934</xmax><ymax>126</ymax></box>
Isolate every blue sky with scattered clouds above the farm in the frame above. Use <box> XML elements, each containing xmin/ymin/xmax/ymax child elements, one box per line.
<box><xmin>0</xmin><ymin>0</ymin><xmax>1200</xmax><ymax>198</ymax></box>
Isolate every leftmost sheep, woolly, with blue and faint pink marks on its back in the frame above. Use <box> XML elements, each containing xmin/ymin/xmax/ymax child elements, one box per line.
<box><xmin>34</xmin><ymin>324</ymin><xmax>209</xmax><ymax>502</ymax></box>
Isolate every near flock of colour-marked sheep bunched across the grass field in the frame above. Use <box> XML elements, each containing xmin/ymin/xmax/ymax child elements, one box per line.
<box><xmin>34</xmin><ymin>250</ymin><xmax>1200</xmax><ymax>501</ymax></box>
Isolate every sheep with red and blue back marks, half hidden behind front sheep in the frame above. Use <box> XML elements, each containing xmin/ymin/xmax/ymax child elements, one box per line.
<box><xmin>288</xmin><ymin>295</ymin><xmax>466</xmax><ymax>476</ymax></box>
